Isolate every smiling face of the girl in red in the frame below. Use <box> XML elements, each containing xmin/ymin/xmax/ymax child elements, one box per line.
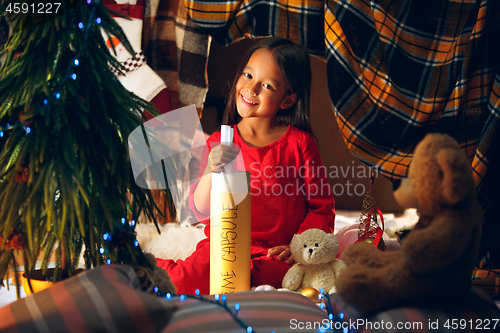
<box><xmin>235</xmin><ymin>48</ymin><xmax>296</xmax><ymax>118</ymax></box>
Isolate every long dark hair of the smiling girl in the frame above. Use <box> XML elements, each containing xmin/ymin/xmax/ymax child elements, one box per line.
<box><xmin>222</xmin><ymin>37</ymin><xmax>311</xmax><ymax>133</ymax></box>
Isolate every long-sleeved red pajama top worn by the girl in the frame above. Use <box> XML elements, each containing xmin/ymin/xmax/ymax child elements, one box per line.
<box><xmin>189</xmin><ymin>126</ymin><xmax>335</xmax><ymax>248</ymax></box>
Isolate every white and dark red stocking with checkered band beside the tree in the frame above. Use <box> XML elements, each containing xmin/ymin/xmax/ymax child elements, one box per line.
<box><xmin>103</xmin><ymin>0</ymin><xmax>172</xmax><ymax>120</ymax></box>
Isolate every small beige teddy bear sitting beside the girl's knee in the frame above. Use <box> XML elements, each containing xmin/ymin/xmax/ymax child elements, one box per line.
<box><xmin>282</xmin><ymin>229</ymin><xmax>346</xmax><ymax>293</ymax></box>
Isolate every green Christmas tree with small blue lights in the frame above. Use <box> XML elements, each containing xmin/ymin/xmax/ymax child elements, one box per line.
<box><xmin>0</xmin><ymin>0</ymin><xmax>170</xmax><ymax>294</ymax></box>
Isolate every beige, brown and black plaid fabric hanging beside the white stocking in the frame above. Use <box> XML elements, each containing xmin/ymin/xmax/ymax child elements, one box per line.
<box><xmin>143</xmin><ymin>0</ymin><xmax>211</xmax><ymax>112</ymax></box>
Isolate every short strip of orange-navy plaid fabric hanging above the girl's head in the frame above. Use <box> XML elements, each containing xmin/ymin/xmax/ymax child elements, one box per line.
<box><xmin>184</xmin><ymin>0</ymin><xmax>325</xmax><ymax>56</ymax></box>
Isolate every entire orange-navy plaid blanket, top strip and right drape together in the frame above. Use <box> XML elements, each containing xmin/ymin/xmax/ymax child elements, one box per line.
<box><xmin>184</xmin><ymin>0</ymin><xmax>500</xmax><ymax>296</ymax></box>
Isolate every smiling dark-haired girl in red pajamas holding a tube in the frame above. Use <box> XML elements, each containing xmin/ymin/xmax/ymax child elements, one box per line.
<box><xmin>158</xmin><ymin>37</ymin><xmax>335</xmax><ymax>294</ymax></box>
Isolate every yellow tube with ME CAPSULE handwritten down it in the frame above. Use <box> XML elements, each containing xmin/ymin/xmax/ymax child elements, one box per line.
<box><xmin>210</xmin><ymin>171</ymin><xmax>251</xmax><ymax>295</ymax></box>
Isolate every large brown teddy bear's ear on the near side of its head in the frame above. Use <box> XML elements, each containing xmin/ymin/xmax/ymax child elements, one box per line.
<box><xmin>436</xmin><ymin>148</ymin><xmax>474</xmax><ymax>206</ymax></box>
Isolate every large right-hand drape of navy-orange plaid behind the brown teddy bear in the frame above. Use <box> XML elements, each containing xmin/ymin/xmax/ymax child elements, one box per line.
<box><xmin>325</xmin><ymin>0</ymin><xmax>500</xmax><ymax>187</ymax></box>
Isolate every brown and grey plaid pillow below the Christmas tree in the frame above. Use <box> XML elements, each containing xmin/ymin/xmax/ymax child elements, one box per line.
<box><xmin>0</xmin><ymin>265</ymin><xmax>176</xmax><ymax>333</ymax></box>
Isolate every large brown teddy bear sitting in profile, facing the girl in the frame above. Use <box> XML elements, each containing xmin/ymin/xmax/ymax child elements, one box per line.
<box><xmin>336</xmin><ymin>134</ymin><xmax>482</xmax><ymax>313</ymax></box>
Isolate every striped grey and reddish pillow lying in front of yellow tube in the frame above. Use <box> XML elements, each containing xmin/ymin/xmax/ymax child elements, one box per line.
<box><xmin>162</xmin><ymin>291</ymin><xmax>329</xmax><ymax>333</ymax></box>
